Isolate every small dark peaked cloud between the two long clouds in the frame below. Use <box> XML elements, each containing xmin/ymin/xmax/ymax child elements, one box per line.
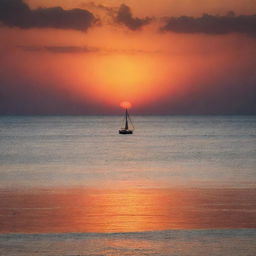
<box><xmin>116</xmin><ymin>4</ymin><xmax>152</xmax><ymax>30</ymax></box>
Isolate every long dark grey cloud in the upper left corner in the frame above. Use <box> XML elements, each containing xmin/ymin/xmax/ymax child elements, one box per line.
<box><xmin>0</xmin><ymin>0</ymin><xmax>96</xmax><ymax>30</ymax></box>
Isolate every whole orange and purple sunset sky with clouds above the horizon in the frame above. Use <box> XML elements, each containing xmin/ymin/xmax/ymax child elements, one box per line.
<box><xmin>0</xmin><ymin>0</ymin><xmax>256</xmax><ymax>115</ymax></box>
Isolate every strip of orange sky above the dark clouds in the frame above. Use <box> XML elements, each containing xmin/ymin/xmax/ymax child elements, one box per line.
<box><xmin>26</xmin><ymin>0</ymin><xmax>256</xmax><ymax>16</ymax></box>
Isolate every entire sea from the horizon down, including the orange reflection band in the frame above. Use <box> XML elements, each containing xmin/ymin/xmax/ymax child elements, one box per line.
<box><xmin>0</xmin><ymin>116</ymin><xmax>256</xmax><ymax>256</ymax></box>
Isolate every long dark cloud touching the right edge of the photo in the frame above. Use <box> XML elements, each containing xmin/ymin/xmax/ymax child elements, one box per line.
<box><xmin>161</xmin><ymin>12</ymin><xmax>256</xmax><ymax>36</ymax></box>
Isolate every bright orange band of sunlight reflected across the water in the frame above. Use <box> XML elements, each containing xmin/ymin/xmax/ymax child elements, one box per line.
<box><xmin>0</xmin><ymin>189</ymin><xmax>256</xmax><ymax>233</ymax></box>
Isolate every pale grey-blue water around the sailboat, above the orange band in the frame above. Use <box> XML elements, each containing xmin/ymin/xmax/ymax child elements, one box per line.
<box><xmin>0</xmin><ymin>116</ymin><xmax>256</xmax><ymax>188</ymax></box>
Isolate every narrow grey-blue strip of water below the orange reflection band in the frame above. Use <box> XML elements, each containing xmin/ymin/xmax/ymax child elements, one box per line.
<box><xmin>0</xmin><ymin>229</ymin><xmax>256</xmax><ymax>256</ymax></box>
